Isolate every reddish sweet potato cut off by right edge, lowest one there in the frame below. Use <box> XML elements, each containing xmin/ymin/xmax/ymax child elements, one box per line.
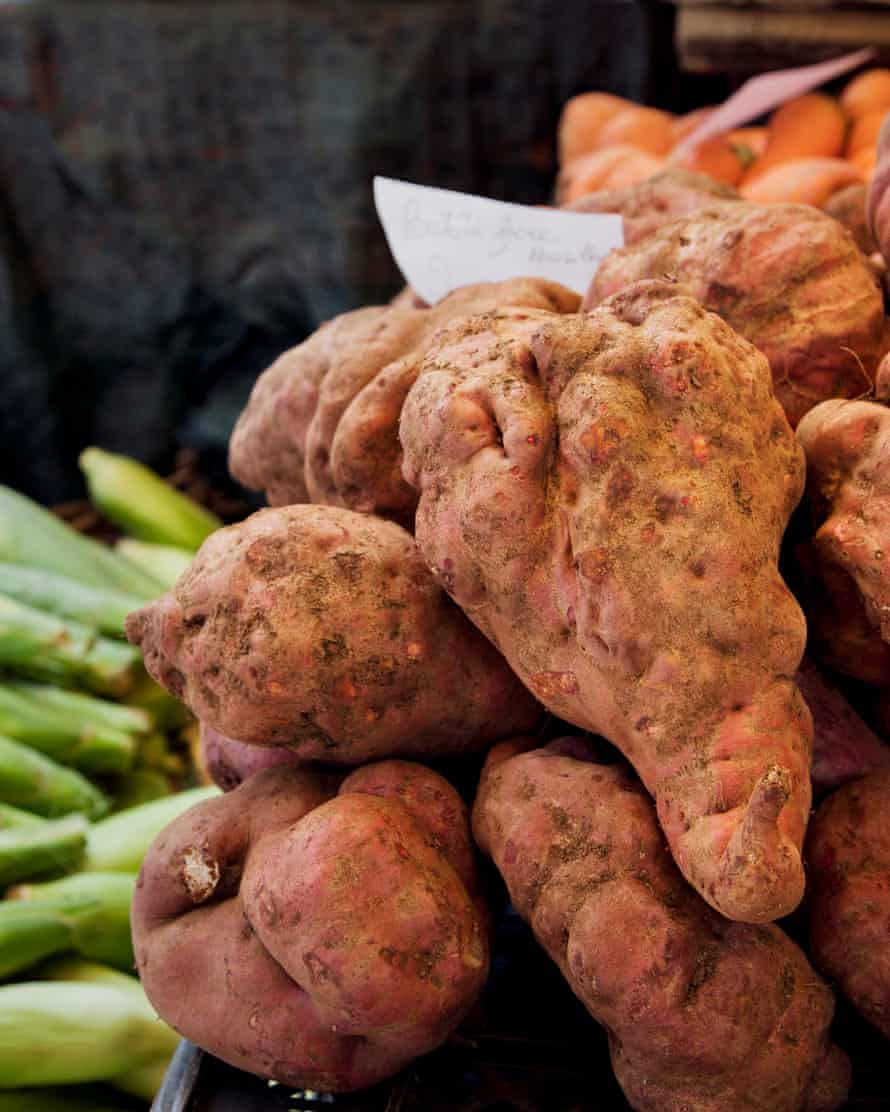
<box><xmin>807</xmin><ymin>771</ymin><xmax>890</xmax><ymax>1039</ymax></box>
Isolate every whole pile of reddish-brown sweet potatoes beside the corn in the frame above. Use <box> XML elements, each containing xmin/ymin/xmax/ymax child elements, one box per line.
<box><xmin>121</xmin><ymin>161</ymin><xmax>890</xmax><ymax>1112</ymax></box>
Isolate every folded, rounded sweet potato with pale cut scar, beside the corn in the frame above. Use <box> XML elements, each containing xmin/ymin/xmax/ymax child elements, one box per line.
<box><xmin>132</xmin><ymin>762</ymin><xmax>488</xmax><ymax>1091</ymax></box>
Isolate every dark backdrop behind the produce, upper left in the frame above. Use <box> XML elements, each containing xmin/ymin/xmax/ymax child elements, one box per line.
<box><xmin>0</xmin><ymin>0</ymin><xmax>725</xmax><ymax>504</ymax></box>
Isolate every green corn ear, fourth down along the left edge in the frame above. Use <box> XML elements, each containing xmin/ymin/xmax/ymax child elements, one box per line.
<box><xmin>0</xmin><ymin>683</ymin><xmax>137</xmax><ymax>773</ymax></box>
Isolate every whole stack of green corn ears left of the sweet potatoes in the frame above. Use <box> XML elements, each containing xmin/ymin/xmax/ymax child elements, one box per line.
<box><xmin>0</xmin><ymin>448</ymin><xmax>220</xmax><ymax>1112</ymax></box>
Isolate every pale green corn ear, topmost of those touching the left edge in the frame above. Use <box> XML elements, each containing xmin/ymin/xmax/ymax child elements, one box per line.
<box><xmin>0</xmin><ymin>485</ymin><xmax>162</xmax><ymax>602</ymax></box>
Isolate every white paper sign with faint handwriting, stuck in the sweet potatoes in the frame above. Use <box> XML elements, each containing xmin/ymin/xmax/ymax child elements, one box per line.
<box><xmin>374</xmin><ymin>177</ymin><xmax>624</xmax><ymax>304</ymax></box>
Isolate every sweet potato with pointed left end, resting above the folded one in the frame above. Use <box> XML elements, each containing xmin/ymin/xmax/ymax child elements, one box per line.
<box><xmin>127</xmin><ymin>505</ymin><xmax>541</xmax><ymax>764</ymax></box>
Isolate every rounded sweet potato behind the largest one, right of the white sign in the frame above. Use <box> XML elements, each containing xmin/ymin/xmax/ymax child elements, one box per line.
<box><xmin>584</xmin><ymin>203</ymin><xmax>883</xmax><ymax>425</ymax></box>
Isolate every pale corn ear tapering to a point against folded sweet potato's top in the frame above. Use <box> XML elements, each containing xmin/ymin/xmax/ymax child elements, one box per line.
<box><xmin>83</xmin><ymin>787</ymin><xmax>221</xmax><ymax>873</ymax></box>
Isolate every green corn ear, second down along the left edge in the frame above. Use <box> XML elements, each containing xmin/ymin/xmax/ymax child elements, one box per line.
<box><xmin>0</xmin><ymin>563</ymin><xmax>144</xmax><ymax>637</ymax></box>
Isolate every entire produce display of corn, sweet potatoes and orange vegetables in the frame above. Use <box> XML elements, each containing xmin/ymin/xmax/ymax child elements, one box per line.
<box><xmin>0</xmin><ymin>56</ymin><xmax>890</xmax><ymax>1112</ymax></box>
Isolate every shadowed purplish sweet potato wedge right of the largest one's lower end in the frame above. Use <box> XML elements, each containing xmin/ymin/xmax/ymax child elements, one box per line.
<box><xmin>795</xmin><ymin>657</ymin><xmax>890</xmax><ymax>795</ymax></box>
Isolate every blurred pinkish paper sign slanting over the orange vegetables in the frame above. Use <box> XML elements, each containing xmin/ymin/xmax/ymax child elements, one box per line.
<box><xmin>675</xmin><ymin>47</ymin><xmax>874</xmax><ymax>156</ymax></box>
